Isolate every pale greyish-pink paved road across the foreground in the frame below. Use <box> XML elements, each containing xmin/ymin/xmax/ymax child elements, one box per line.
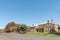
<box><xmin>0</xmin><ymin>33</ymin><xmax>60</xmax><ymax>40</ymax></box>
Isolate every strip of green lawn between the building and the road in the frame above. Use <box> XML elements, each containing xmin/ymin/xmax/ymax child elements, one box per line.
<box><xmin>27</xmin><ymin>32</ymin><xmax>60</xmax><ymax>37</ymax></box>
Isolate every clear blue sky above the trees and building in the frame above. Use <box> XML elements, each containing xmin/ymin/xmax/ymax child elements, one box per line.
<box><xmin>0</xmin><ymin>0</ymin><xmax>60</xmax><ymax>29</ymax></box>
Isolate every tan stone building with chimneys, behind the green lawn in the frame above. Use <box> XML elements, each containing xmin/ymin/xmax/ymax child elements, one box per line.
<box><xmin>31</xmin><ymin>20</ymin><xmax>60</xmax><ymax>32</ymax></box>
